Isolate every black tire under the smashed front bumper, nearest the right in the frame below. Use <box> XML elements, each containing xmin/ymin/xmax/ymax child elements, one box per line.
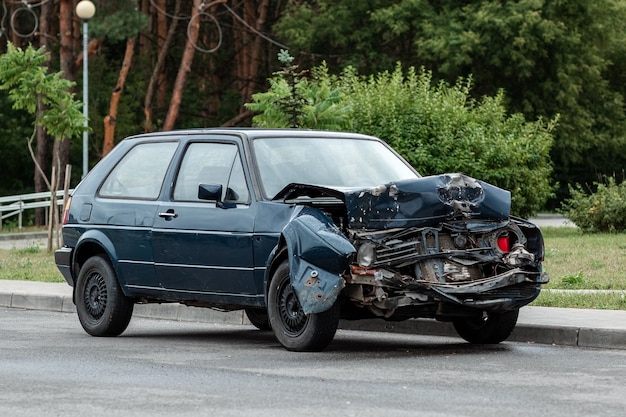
<box><xmin>452</xmin><ymin>309</ymin><xmax>519</xmax><ymax>345</ymax></box>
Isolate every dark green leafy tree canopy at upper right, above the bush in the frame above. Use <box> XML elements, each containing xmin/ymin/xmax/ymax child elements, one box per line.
<box><xmin>276</xmin><ymin>0</ymin><xmax>626</xmax><ymax>205</ymax></box>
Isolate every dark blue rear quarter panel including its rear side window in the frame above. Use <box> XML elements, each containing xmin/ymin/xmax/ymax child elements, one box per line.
<box><xmin>94</xmin><ymin>140</ymin><xmax>179</xmax><ymax>291</ymax></box>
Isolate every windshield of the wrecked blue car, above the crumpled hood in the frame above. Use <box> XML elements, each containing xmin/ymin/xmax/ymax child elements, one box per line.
<box><xmin>254</xmin><ymin>137</ymin><xmax>418</xmax><ymax>197</ymax></box>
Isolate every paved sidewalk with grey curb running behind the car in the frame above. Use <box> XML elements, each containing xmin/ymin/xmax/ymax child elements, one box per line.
<box><xmin>0</xmin><ymin>280</ymin><xmax>626</xmax><ymax>349</ymax></box>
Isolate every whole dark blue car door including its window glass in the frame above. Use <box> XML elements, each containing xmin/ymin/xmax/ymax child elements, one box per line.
<box><xmin>152</xmin><ymin>141</ymin><xmax>259</xmax><ymax>304</ymax></box>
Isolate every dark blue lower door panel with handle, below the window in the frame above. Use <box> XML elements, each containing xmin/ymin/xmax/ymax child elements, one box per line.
<box><xmin>150</xmin><ymin>202</ymin><xmax>262</xmax><ymax>297</ymax></box>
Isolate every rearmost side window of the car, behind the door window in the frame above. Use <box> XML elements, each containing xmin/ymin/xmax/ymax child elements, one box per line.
<box><xmin>99</xmin><ymin>142</ymin><xmax>178</xmax><ymax>200</ymax></box>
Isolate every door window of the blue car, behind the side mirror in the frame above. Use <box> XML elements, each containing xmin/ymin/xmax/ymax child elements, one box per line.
<box><xmin>174</xmin><ymin>143</ymin><xmax>250</xmax><ymax>203</ymax></box>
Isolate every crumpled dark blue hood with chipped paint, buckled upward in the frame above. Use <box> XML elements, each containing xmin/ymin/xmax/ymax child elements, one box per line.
<box><xmin>275</xmin><ymin>173</ymin><xmax>511</xmax><ymax>229</ymax></box>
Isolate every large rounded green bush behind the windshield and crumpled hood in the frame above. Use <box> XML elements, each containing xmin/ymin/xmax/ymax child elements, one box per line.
<box><xmin>342</xmin><ymin>66</ymin><xmax>556</xmax><ymax>217</ymax></box>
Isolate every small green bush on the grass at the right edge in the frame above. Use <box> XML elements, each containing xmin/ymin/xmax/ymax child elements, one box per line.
<box><xmin>562</xmin><ymin>177</ymin><xmax>626</xmax><ymax>233</ymax></box>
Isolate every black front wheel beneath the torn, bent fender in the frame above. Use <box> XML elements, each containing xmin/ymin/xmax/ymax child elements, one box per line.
<box><xmin>267</xmin><ymin>261</ymin><xmax>339</xmax><ymax>352</ymax></box>
